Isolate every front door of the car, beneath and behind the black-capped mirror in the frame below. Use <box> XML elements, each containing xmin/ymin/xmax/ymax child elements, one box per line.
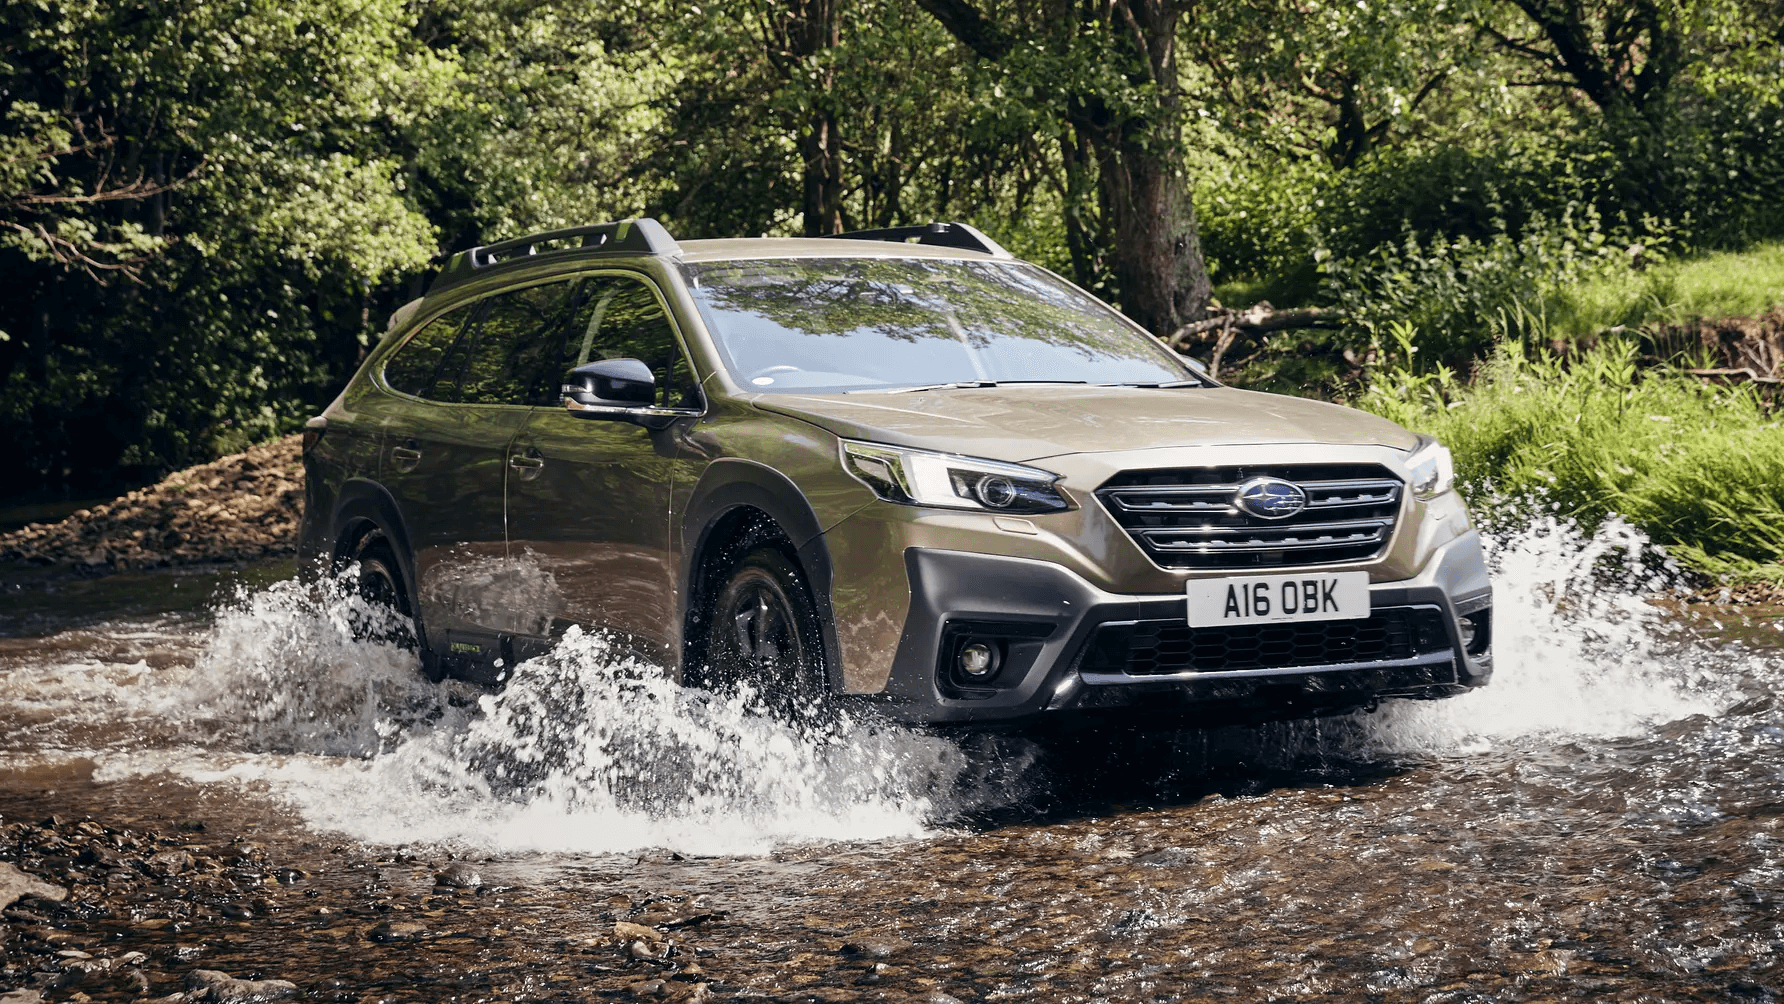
<box><xmin>508</xmin><ymin>273</ymin><xmax>699</xmax><ymax>660</ymax></box>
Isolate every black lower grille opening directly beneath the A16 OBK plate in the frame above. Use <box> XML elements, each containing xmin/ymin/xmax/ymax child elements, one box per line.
<box><xmin>1079</xmin><ymin>606</ymin><xmax>1450</xmax><ymax>676</ymax></box>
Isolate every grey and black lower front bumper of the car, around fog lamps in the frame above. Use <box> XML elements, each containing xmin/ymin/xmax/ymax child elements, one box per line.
<box><xmin>871</xmin><ymin>530</ymin><xmax>1491</xmax><ymax>726</ymax></box>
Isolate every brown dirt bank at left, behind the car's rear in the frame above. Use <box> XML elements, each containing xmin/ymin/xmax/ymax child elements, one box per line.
<box><xmin>0</xmin><ymin>435</ymin><xmax>303</xmax><ymax>571</ymax></box>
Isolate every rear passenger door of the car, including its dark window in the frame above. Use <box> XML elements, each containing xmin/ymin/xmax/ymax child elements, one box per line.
<box><xmin>385</xmin><ymin>282</ymin><xmax>569</xmax><ymax>679</ymax></box>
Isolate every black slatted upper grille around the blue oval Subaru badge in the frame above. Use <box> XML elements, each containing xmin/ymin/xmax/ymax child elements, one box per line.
<box><xmin>1097</xmin><ymin>464</ymin><xmax>1402</xmax><ymax>569</ymax></box>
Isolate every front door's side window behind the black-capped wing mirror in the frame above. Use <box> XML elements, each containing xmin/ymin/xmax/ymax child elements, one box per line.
<box><xmin>553</xmin><ymin>275</ymin><xmax>699</xmax><ymax>408</ymax></box>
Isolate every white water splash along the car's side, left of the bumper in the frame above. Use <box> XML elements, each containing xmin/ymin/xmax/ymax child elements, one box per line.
<box><xmin>86</xmin><ymin>580</ymin><xmax>963</xmax><ymax>854</ymax></box>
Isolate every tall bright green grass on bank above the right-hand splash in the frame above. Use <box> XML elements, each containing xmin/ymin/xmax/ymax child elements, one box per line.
<box><xmin>1358</xmin><ymin>342</ymin><xmax>1784</xmax><ymax>581</ymax></box>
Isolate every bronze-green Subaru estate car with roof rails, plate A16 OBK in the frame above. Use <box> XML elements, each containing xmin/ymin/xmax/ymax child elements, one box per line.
<box><xmin>300</xmin><ymin>219</ymin><xmax>1491</xmax><ymax>729</ymax></box>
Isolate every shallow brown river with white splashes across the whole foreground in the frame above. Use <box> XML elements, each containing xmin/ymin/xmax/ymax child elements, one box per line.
<box><xmin>0</xmin><ymin>523</ymin><xmax>1784</xmax><ymax>1002</ymax></box>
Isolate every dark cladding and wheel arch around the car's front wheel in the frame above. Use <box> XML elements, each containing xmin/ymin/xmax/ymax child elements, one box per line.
<box><xmin>680</xmin><ymin>458</ymin><xmax>842</xmax><ymax>694</ymax></box>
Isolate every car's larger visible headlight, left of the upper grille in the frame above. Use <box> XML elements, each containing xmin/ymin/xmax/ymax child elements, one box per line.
<box><xmin>842</xmin><ymin>439</ymin><xmax>1072</xmax><ymax>512</ymax></box>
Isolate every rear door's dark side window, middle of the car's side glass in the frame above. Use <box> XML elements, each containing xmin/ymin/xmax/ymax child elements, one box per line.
<box><xmin>458</xmin><ymin>282</ymin><xmax>576</xmax><ymax>405</ymax></box>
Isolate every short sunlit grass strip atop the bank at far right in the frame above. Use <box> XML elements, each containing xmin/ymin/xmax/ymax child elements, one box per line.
<box><xmin>1543</xmin><ymin>243</ymin><xmax>1784</xmax><ymax>339</ymax></box>
